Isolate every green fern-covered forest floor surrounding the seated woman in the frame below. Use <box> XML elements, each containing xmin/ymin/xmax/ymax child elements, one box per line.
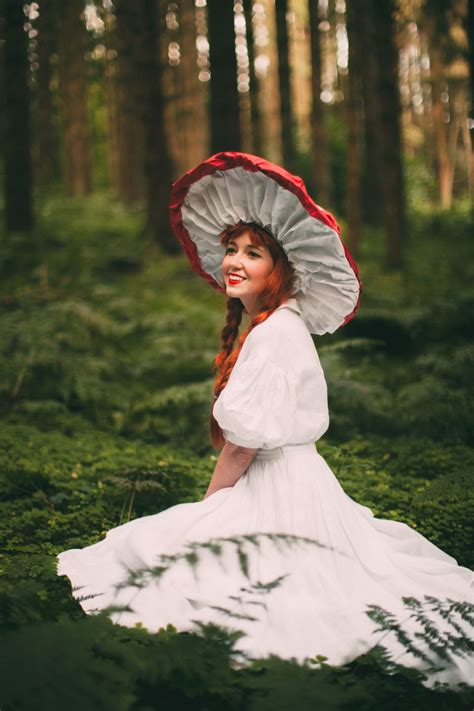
<box><xmin>0</xmin><ymin>195</ymin><xmax>474</xmax><ymax>711</ymax></box>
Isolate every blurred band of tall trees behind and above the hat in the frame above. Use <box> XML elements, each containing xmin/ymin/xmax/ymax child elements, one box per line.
<box><xmin>0</xmin><ymin>0</ymin><xmax>474</xmax><ymax>256</ymax></box>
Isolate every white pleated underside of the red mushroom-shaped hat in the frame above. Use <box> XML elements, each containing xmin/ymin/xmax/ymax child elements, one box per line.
<box><xmin>181</xmin><ymin>167</ymin><xmax>359</xmax><ymax>334</ymax></box>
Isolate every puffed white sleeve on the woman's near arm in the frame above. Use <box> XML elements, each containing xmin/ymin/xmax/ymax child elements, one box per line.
<box><xmin>213</xmin><ymin>356</ymin><xmax>297</xmax><ymax>449</ymax></box>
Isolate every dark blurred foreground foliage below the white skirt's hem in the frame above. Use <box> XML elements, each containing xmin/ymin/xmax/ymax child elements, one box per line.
<box><xmin>0</xmin><ymin>616</ymin><xmax>473</xmax><ymax>711</ymax></box>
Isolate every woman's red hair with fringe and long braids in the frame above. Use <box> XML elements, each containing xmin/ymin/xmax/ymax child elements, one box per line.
<box><xmin>210</xmin><ymin>222</ymin><xmax>295</xmax><ymax>449</ymax></box>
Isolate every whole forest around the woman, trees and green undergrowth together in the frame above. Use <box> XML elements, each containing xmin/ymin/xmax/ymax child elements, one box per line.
<box><xmin>0</xmin><ymin>0</ymin><xmax>474</xmax><ymax>711</ymax></box>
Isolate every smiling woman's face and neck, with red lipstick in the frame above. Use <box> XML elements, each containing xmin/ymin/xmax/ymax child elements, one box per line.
<box><xmin>222</xmin><ymin>231</ymin><xmax>274</xmax><ymax>317</ymax></box>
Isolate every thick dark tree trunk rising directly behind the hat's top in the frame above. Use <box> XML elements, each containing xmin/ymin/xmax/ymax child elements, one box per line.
<box><xmin>207</xmin><ymin>0</ymin><xmax>242</xmax><ymax>153</ymax></box>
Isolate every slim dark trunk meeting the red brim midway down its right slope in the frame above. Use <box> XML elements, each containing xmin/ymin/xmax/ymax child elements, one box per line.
<box><xmin>308</xmin><ymin>0</ymin><xmax>331</xmax><ymax>207</ymax></box>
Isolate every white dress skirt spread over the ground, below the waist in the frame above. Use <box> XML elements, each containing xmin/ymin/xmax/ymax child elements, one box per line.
<box><xmin>58</xmin><ymin>442</ymin><xmax>474</xmax><ymax>684</ymax></box>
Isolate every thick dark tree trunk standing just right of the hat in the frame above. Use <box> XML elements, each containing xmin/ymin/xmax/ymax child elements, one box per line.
<box><xmin>373</xmin><ymin>0</ymin><xmax>406</xmax><ymax>269</ymax></box>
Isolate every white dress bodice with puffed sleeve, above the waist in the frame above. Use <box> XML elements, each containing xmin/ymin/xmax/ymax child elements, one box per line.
<box><xmin>213</xmin><ymin>299</ymin><xmax>329</xmax><ymax>449</ymax></box>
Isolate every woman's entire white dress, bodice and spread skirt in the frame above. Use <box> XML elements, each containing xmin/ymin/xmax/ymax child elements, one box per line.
<box><xmin>58</xmin><ymin>299</ymin><xmax>474</xmax><ymax>683</ymax></box>
